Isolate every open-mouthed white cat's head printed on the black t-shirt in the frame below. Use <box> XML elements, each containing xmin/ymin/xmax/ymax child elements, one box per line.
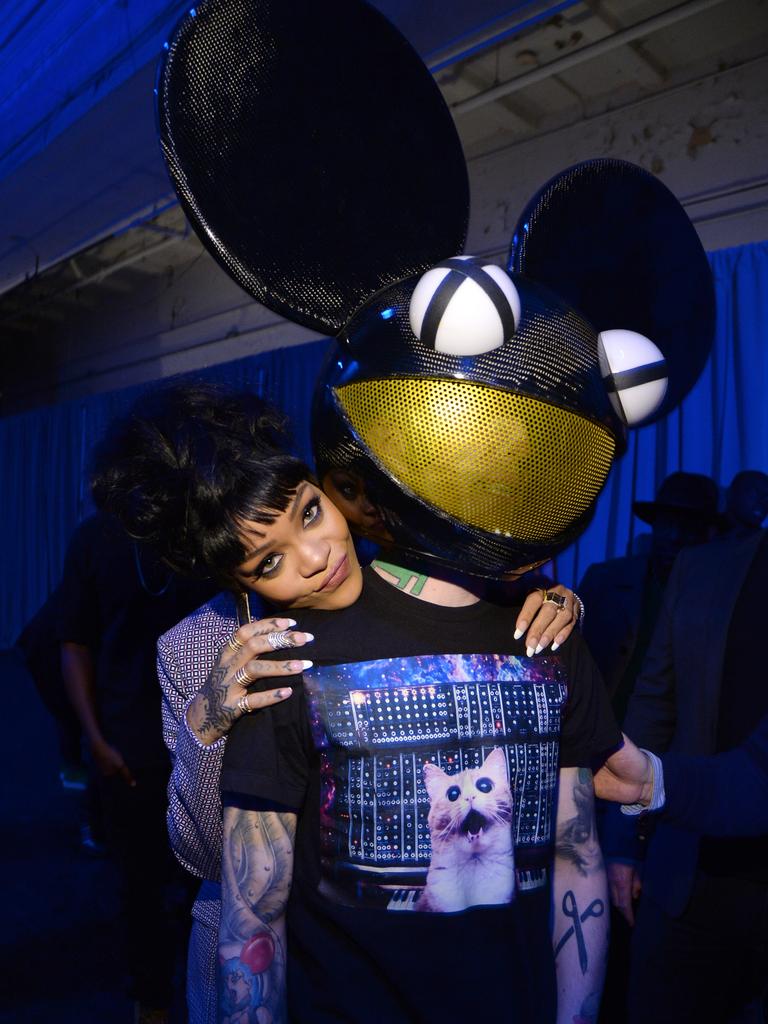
<box><xmin>424</xmin><ymin>748</ymin><xmax>512</xmax><ymax>846</ymax></box>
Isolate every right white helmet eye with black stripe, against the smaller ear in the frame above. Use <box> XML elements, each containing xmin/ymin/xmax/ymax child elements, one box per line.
<box><xmin>597</xmin><ymin>329</ymin><xmax>669</xmax><ymax>427</ymax></box>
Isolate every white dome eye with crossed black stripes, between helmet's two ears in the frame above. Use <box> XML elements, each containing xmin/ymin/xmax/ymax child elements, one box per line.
<box><xmin>409</xmin><ymin>256</ymin><xmax>520</xmax><ymax>356</ymax></box>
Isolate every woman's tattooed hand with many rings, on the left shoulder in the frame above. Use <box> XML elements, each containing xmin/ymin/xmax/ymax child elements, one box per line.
<box><xmin>186</xmin><ymin>618</ymin><xmax>314</xmax><ymax>745</ymax></box>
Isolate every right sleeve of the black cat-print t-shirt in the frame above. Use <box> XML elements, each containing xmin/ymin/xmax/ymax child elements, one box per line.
<box><xmin>560</xmin><ymin>631</ymin><xmax>622</xmax><ymax>768</ymax></box>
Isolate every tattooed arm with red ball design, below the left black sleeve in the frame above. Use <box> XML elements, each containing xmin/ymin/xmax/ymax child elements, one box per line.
<box><xmin>218</xmin><ymin>808</ymin><xmax>296</xmax><ymax>1024</ymax></box>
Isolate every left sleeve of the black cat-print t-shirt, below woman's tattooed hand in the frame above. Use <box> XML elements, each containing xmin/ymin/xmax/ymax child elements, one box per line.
<box><xmin>221</xmin><ymin>679</ymin><xmax>312</xmax><ymax>811</ymax></box>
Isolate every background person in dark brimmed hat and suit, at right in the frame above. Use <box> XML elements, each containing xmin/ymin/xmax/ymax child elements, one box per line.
<box><xmin>579</xmin><ymin>473</ymin><xmax>718</xmax><ymax>722</ymax></box>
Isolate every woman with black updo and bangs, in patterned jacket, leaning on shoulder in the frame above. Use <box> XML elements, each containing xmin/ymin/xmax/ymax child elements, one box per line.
<box><xmin>93</xmin><ymin>385</ymin><xmax>593</xmax><ymax>1021</ymax></box>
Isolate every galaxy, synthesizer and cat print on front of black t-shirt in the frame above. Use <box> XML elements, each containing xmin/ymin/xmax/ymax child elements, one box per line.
<box><xmin>304</xmin><ymin>654</ymin><xmax>567</xmax><ymax>912</ymax></box>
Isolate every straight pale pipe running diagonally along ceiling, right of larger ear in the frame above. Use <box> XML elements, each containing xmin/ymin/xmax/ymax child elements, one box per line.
<box><xmin>451</xmin><ymin>0</ymin><xmax>724</xmax><ymax>116</ymax></box>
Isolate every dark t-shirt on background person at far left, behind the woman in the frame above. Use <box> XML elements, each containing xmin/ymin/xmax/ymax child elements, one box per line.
<box><xmin>55</xmin><ymin>513</ymin><xmax>216</xmax><ymax>771</ymax></box>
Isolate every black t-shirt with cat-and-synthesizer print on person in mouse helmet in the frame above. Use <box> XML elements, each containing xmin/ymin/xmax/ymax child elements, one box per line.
<box><xmin>222</xmin><ymin>570</ymin><xmax>621</xmax><ymax>1024</ymax></box>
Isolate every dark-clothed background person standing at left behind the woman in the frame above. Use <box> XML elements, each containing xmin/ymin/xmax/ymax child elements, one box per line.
<box><xmin>55</xmin><ymin>512</ymin><xmax>217</xmax><ymax>1024</ymax></box>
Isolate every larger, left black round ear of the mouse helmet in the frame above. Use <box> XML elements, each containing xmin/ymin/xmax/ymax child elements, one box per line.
<box><xmin>157</xmin><ymin>0</ymin><xmax>469</xmax><ymax>333</ymax></box>
